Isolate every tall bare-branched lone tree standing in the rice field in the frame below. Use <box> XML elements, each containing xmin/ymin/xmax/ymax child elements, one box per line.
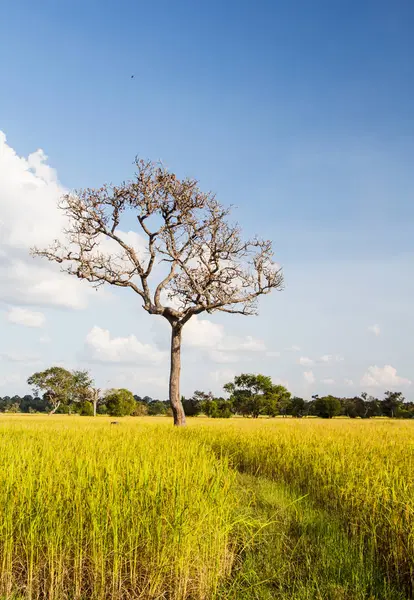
<box><xmin>32</xmin><ymin>160</ymin><xmax>283</xmax><ymax>425</ymax></box>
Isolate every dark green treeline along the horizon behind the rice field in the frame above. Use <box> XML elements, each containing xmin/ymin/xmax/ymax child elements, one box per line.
<box><xmin>0</xmin><ymin>367</ymin><xmax>414</xmax><ymax>419</ymax></box>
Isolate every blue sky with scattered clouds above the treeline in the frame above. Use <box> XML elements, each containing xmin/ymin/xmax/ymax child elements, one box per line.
<box><xmin>0</xmin><ymin>0</ymin><xmax>414</xmax><ymax>397</ymax></box>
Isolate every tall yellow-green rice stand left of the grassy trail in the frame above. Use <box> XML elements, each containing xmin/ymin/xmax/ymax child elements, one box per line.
<box><xmin>0</xmin><ymin>417</ymin><xmax>236</xmax><ymax>600</ymax></box>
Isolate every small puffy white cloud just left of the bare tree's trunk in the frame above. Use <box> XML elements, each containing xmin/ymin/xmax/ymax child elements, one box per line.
<box><xmin>85</xmin><ymin>326</ymin><xmax>165</xmax><ymax>365</ymax></box>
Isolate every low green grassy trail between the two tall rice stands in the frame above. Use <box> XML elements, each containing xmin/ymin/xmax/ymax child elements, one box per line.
<box><xmin>222</xmin><ymin>474</ymin><xmax>406</xmax><ymax>600</ymax></box>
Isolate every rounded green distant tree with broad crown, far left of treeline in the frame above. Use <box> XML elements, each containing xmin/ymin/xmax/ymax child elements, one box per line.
<box><xmin>27</xmin><ymin>367</ymin><xmax>73</xmax><ymax>415</ymax></box>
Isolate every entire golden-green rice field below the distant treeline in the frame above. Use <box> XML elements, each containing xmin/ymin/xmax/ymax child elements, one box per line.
<box><xmin>0</xmin><ymin>415</ymin><xmax>414</xmax><ymax>600</ymax></box>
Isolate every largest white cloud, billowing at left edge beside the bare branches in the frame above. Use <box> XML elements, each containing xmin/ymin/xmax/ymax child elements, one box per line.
<box><xmin>0</xmin><ymin>131</ymin><xmax>89</xmax><ymax>308</ymax></box>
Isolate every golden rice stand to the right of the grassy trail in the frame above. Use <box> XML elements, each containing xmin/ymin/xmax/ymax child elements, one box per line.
<box><xmin>187</xmin><ymin>419</ymin><xmax>414</xmax><ymax>597</ymax></box>
